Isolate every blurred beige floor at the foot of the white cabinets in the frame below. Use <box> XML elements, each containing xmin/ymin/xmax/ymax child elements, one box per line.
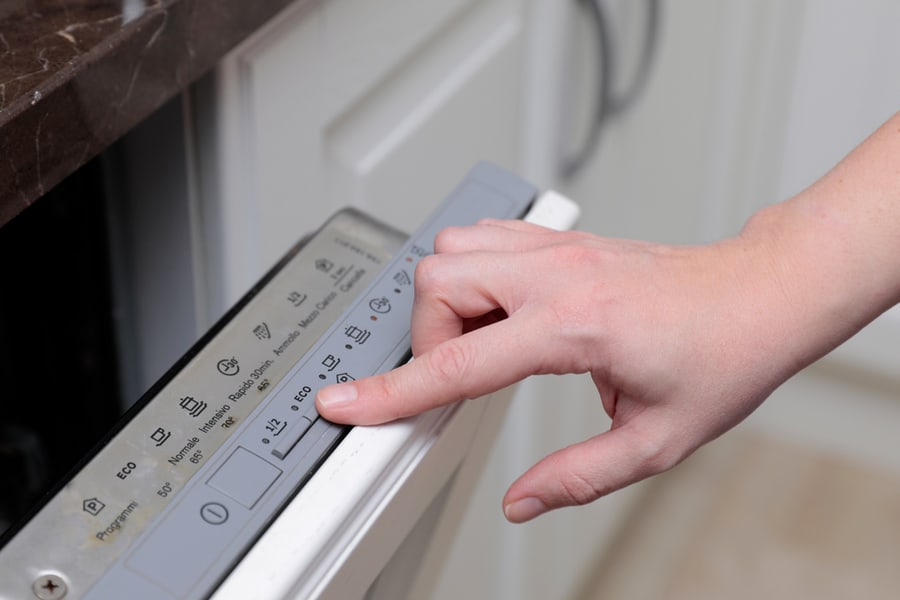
<box><xmin>581</xmin><ymin>432</ymin><xmax>900</xmax><ymax>600</ymax></box>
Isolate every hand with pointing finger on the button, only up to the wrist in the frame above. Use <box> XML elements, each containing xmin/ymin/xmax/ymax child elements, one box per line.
<box><xmin>318</xmin><ymin>221</ymin><xmax>800</xmax><ymax>522</ymax></box>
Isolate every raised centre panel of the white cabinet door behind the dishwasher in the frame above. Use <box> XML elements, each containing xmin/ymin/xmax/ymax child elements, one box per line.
<box><xmin>325</xmin><ymin>11</ymin><xmax>522</xmax><ymax>231</ymax></box>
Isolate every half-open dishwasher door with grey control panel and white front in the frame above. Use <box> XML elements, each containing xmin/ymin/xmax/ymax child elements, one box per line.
<box><xmin>0</xmin><ymin>163</ymin><xmax>577</xmax><ymax>600</ymax></box>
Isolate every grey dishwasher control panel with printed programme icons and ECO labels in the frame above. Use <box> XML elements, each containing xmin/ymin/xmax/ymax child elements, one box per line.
<box><xmin>0</xmin><ymin>163</ymin><xmax>537</xmax><ymax>600</ymax></box>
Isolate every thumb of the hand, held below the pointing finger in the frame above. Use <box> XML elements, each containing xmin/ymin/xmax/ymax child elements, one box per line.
<box><xmin>503</xmin><ymin>424</ymin><xmax>682</xmax><ymax>523</ymax></box>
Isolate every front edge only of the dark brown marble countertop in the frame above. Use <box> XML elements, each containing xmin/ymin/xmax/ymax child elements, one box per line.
<box><xmin>0</xmin><ymin>0</ymin><xmax>303</xmax><ymax>226</ymax></box>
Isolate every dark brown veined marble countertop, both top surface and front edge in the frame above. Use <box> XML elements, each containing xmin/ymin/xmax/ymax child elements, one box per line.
<box><xmin>0</xmin><ymin>0</ymin><xmax>302</xmax><ymax>226</ymax></box>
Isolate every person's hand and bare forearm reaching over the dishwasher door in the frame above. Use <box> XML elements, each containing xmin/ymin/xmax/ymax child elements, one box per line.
<box><xmin>317</xmin><ymin>115</ymin><xmax>900</xmax><ymax>522</ymax></box>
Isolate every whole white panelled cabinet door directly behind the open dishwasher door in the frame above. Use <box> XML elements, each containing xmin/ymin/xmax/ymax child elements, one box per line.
<box><xmin>197</xmin><ymin>0</ymin><xmax>523</xmax><ymax>322</ymax></box>
